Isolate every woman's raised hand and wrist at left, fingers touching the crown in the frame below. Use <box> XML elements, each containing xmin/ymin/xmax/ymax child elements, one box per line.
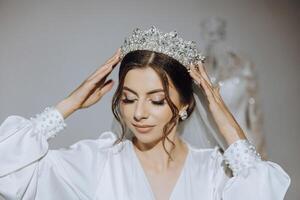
<box><xmin>56</xmin><ymin>49</ymin><xmax>121</xmax><ymax>118</ymax></box>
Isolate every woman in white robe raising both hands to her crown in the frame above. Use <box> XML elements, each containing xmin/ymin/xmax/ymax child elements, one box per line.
<box><xmin>0</xmin><ymin>29</ymin><xmax>290</xmax><ymax>200</ymax></box>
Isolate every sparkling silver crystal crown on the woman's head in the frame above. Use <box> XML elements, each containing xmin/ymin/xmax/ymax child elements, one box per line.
<box><xmin>121</xmin><ymin>26</ymin><xmax>205</xmax><ymax>69</ymax></box>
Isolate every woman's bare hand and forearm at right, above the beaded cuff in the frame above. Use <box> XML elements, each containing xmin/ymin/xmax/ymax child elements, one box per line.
<box><xmin>189</xmin><ymin>62</ymin><xmax>246</xmax><ymax>145</ymax></box>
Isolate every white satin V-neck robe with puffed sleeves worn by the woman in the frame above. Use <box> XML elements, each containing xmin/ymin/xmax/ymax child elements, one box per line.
<box><xmin>0</xmin><ymin>107</ymin><xmax>290</xmax><ymax>200</ymax></box>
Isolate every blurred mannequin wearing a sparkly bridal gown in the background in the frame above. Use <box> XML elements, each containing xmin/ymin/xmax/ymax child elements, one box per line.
<box><xmin>202</xmin><ymin>18</ymin><xmax>267</xmax><ymax>158</ymax></box>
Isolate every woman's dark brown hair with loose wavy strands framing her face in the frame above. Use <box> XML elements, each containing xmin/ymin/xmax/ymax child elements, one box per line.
<box><xmin>112</xmin><ymin>50</ymin><xmax>195</xmax><ymax>159</ymax></box>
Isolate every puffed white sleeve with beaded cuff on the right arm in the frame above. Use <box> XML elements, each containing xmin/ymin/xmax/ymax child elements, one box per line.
<box><xmin>214</xmin><ymin>140</ymin><xmax>291</xmax><ymax>200</ymax></box>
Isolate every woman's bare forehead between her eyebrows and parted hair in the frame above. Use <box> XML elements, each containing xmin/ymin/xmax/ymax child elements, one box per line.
<box><xmin>124</xmin><ymin>67</ymin><xmax>174</xmax><ymax>93</ymax></box>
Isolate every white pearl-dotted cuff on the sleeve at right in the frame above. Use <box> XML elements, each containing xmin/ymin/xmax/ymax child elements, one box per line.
<box><xmin>223</xmin><ymin>140</ymin><xmax>261</xmax><ymax>176</ymax></box>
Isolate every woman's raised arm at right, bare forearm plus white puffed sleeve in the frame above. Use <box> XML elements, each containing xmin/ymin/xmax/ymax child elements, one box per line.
<box><xmin>189</xmin><ymin>63</ymin><xmax>290</xmax><ymax>200</ymax></box>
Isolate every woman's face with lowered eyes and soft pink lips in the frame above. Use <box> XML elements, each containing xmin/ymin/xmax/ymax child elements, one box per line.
<box><xmin>120</xmin><ymin>67</ymin><xmax>182</xmax><ymax>143</ymax></box>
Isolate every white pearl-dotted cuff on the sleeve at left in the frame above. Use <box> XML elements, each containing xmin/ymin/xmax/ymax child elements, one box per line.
<box><xmin>30</xmin><ymin>106</ymin><xmax>67</xmax><ymax>139</ymax></box>
